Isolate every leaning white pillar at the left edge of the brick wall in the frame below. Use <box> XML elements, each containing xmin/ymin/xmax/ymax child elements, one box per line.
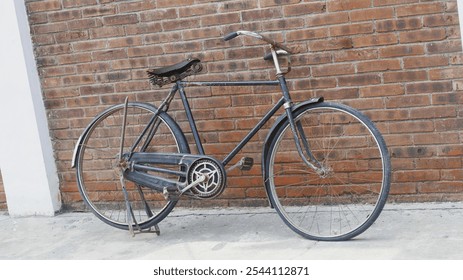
<box><xmin>0</xmin><ymin>0</ymin><xmax>61</xmax><ymax>216</ymax></box>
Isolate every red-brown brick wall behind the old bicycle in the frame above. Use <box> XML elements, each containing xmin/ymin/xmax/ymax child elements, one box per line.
<box><xmin>26</xmin><ymin>0</ymin><xmax>463</xmax><ymax>209</ymax></box>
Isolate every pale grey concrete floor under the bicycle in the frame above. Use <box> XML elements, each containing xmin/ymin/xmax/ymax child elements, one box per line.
<box><xmin>0</xmin><ymin>203</ymin><xmax>463</xmax><ymax>260</ymax></box>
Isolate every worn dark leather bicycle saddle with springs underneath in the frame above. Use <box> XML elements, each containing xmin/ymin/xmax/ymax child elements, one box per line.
<box><xmin>147</xmin><ymin>58</ymin><xmax>203</xmax><ymax>87</ymax></box>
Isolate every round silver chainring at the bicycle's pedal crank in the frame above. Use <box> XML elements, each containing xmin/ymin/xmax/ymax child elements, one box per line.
<box><xmin>188</xmin><ymin>158</ymin><xmax>226</xmax><ymax>199</ymax></box>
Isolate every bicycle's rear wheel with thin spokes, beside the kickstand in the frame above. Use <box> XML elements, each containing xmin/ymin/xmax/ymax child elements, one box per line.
<box><xmin>76</xmin><ymin>103</ymin><xmax>189</xmax><ymax>230</ymax></box>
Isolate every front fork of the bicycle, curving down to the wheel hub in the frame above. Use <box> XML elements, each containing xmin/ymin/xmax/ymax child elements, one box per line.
<box><xmin>277</xmin><ymin>75</ymin><xmax>328</xmax><ymax>176</ymax></box>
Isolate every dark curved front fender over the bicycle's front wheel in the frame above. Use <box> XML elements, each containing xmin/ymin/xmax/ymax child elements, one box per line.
<box><xmin>261</xmin><ymin>97</ymin><xmax>324</xmax><ymax>208</ymax></box>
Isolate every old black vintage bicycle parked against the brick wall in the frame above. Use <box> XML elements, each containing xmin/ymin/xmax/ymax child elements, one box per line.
<box><xmin>72</xmin><ymin>31</ymin><xmax>391</xmax><ymax>241</ymax></box>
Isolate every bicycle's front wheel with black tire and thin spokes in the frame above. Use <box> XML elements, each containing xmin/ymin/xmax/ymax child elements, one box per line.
<box><xmin>264</xmin><ymin>103</ymin><xmax>390</xmax><ymax>241</ymax></box>
